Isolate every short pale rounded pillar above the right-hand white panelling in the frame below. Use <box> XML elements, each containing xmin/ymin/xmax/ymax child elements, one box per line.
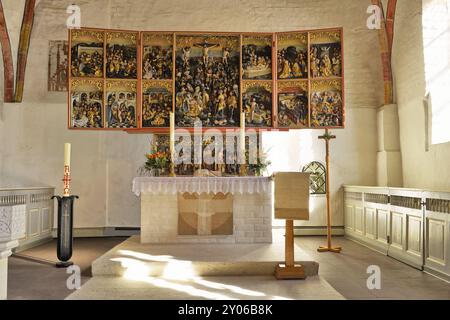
<box><xmin>377</xmin><ymin>104</ymin><xmax>403</xmax><ymax>187</ymax></box>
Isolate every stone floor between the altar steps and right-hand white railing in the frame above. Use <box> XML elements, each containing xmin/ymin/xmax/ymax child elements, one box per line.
<box><xmin>295</xmin><ymin>237</ymin><xmax>450</xmax><ymax>300</ymax></box>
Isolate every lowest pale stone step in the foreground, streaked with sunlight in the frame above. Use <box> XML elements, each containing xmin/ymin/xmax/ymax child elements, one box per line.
<box><xmin>67</xmin><ymin>276</ymin><xmax>344</xmax><ymax>300</ymax></box>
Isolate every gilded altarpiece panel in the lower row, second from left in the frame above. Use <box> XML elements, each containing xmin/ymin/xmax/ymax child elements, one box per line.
<box><xmin>105</xmin><ymin>80</ymin><xmax>137</xmax><ymax>129</ymax></box>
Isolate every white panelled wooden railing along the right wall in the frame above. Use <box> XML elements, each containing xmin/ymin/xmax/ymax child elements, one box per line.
<box><xmin>344</xmin><ymin>186</ymin><xmax>450</xmax><ymax>280</ymax></box>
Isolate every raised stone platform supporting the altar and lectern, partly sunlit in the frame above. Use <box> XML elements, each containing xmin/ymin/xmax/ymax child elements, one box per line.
<box><xmin>92</xmin><ymin>236</ymin><xmax>319</xmax><ymax>278</ymax></box>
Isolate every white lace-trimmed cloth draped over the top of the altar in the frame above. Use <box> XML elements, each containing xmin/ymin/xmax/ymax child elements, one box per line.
<box><xmin>133</xmin><ymin>177</ymin><xmax>272</xmax><ymax>196</ymax></box>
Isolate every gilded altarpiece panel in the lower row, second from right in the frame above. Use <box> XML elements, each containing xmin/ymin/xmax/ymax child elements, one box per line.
<box><xmin>277</xmin><ymin>80</ymin><xmax>309</xmax><ymax>129</ymax></box>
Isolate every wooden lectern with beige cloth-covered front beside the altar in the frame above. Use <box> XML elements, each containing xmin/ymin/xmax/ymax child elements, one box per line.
<box><xmin>274</xmin><ymin>172</ymin><xmax>309</xmax><ymax>280</ymax></box>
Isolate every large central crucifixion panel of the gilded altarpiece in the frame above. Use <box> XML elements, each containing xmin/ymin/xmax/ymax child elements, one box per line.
<box><xmin>175</xmin><ymin>34</ymin><xmax>240</xmax><ymax>127</ymax></box>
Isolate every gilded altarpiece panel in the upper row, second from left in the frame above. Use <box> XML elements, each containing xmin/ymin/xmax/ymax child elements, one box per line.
<box><xmin>106</xmin><ymin>31</ymin><xmax>139</xmax><ymax>79</ymax></box>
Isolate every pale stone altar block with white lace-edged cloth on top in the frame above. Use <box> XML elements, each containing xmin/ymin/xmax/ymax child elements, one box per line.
<box><xmin>133</xmin><ymin>177</ymin><xmax>273</xmax><ymax>243</ymax></box>
